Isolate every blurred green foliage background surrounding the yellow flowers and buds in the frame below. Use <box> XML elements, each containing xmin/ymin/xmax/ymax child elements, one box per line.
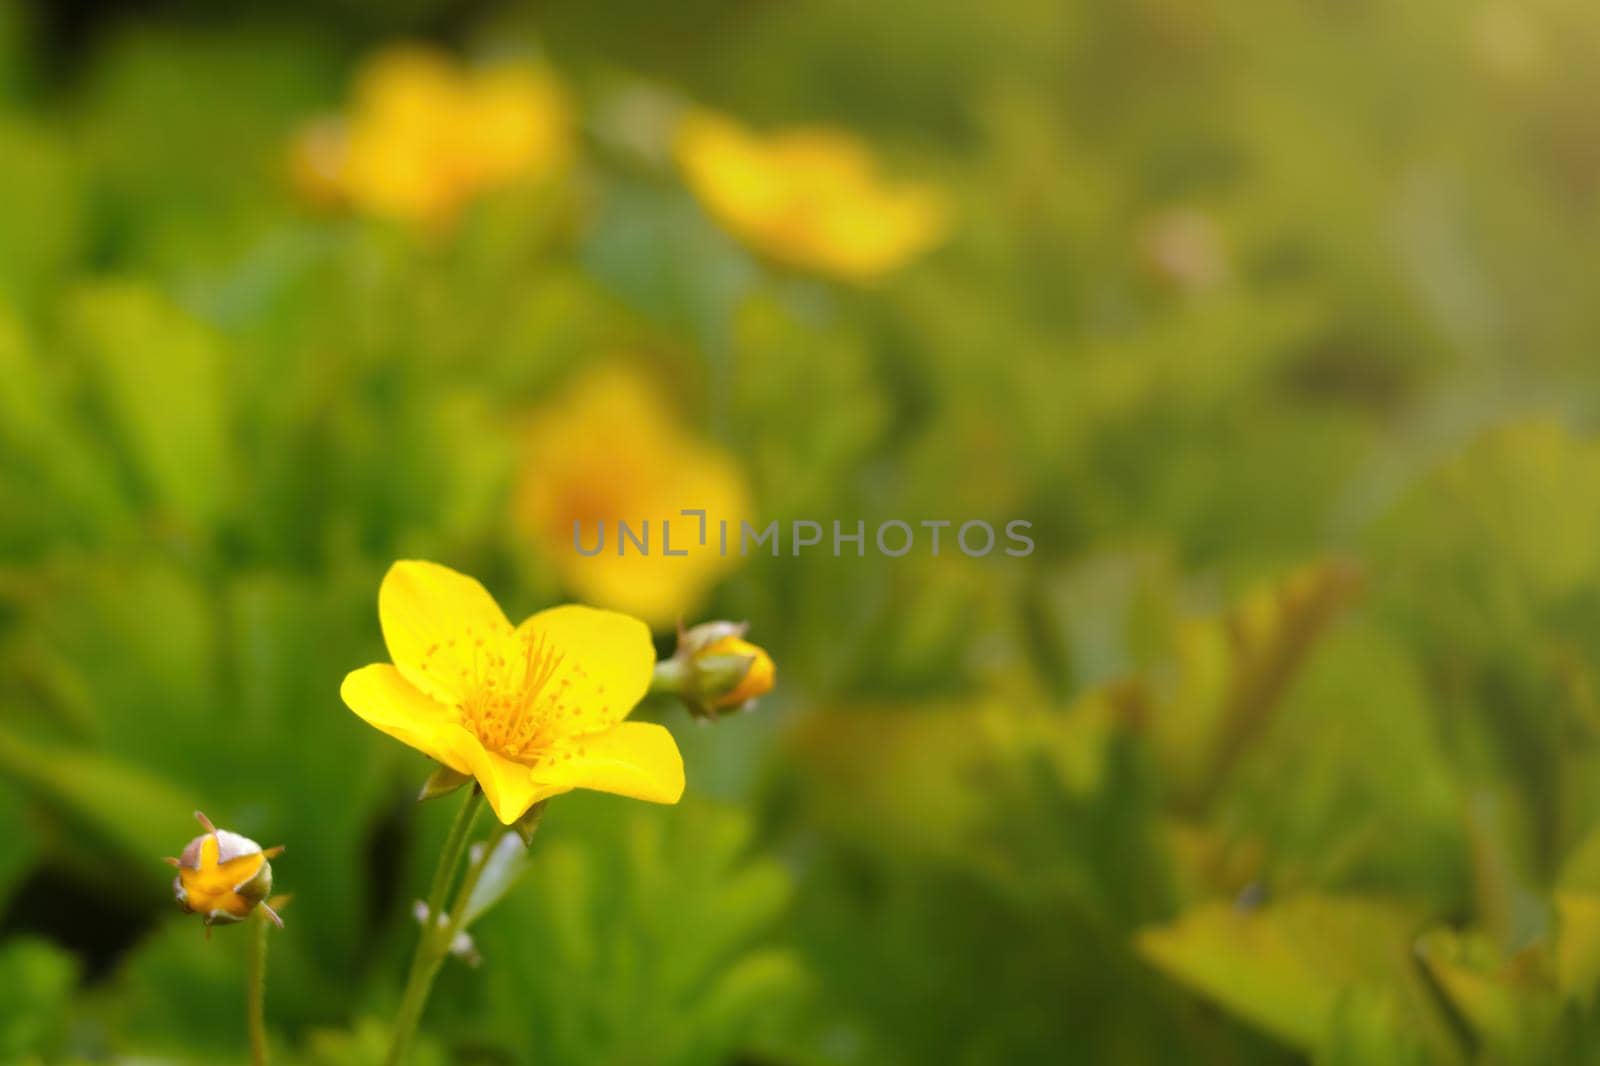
<box><xmin>0</xmin><ymin>0</ymin><xmax>1600</xmax><ymax>1066</ymax></box>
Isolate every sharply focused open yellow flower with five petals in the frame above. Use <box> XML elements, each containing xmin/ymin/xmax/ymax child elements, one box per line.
<box><xmin>339</xmin><ymin>562</ymin><xmax>683</xmax><ymax>826</ymax></box>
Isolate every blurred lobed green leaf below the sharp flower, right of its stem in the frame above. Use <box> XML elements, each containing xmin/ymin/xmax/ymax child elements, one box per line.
<box><xmin>474</xmin><ymin>797</ymin><xmax>802</xmax><ymax>1064</ymax></box>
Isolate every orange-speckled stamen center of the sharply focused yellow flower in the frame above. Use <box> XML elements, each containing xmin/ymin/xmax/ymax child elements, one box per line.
<box><xmin>459</xmin><ymin>634</ymin><xmax>582</xmax><ymax>762</ymax></box>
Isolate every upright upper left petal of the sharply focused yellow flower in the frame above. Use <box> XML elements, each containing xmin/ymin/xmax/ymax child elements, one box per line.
<box><xmin>378</xmin><ymin>560</ymin><xmax>512</xmax><ymax>706</ymax></box>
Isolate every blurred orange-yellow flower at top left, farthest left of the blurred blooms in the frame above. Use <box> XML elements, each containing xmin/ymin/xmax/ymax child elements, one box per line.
<box><xmin>290</xmin><ymin>48</ymin><xmax>573</xmax><ymax>222</ymax></box>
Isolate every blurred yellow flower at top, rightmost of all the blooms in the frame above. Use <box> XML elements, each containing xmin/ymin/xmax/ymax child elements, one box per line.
<box><xmin>677</xmin><ymin>114</ymin><xmax>949</xmax><ymax>282</ymax></box>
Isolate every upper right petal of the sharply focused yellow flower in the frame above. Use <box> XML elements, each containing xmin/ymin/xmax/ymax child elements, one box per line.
<box><xmin>517</xmin><ymin>603</ymin><xmax>656</xmax><ymax>731</ymax></box>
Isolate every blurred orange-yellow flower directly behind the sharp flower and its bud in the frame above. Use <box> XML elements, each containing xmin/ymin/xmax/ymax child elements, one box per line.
<box><xmin>514</xmin><ymin>363</ymin><xmax>749</xmax><ymax>626</ymax></box>
